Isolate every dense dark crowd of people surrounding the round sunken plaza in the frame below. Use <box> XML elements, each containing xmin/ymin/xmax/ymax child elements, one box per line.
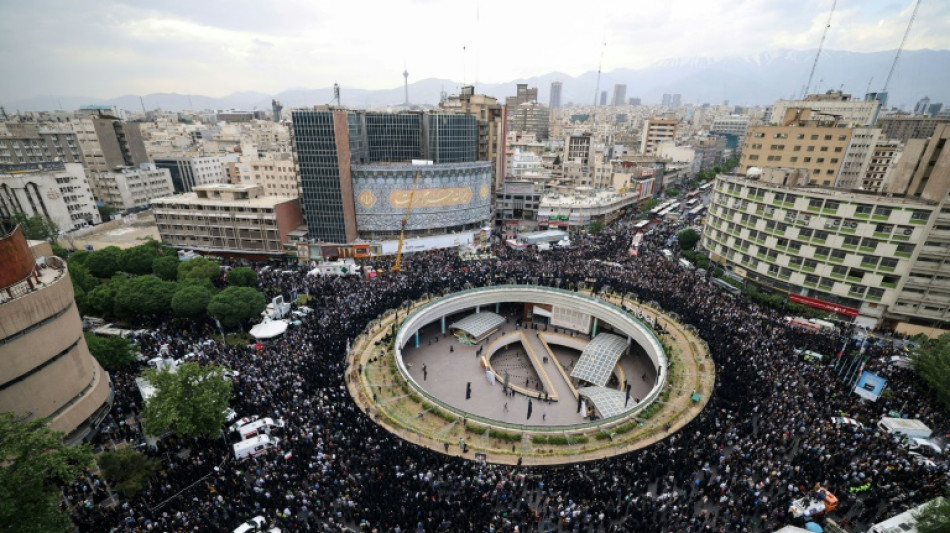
<box><xmin>66</xmin><ymin>206</ymin><xmax>950</xmax><ymax>533</ymax></box>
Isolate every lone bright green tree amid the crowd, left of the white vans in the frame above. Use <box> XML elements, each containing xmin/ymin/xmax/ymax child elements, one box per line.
<box><xmin>143</xmin><ymin>363</ymin><xmax>231</xmax><ymax>439</ymax></box>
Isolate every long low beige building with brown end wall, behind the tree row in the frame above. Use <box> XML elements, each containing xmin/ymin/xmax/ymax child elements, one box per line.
<box><xmin>152</xmin><ymin>183</ymin><xmax>303</xmax><ymax>259</ymax></box>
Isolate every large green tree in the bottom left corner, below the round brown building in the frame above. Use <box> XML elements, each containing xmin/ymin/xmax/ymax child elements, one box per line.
<box><xmin>0</xmin><ymin>413</ymin><xmax>93</xmax><ymax>532</ymax></box>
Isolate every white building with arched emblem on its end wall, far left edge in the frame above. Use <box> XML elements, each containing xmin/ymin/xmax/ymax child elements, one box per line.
<box><xmin>0</xmin><ymin>163</ymin><xmax>102</xmax><ymax>231</ymax></box>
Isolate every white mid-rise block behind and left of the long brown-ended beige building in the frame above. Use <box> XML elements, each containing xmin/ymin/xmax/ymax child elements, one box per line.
<box><xmin>95</xmin><ymin>163</ymin><xmax>175</xmax><ymax>210</ymax></box>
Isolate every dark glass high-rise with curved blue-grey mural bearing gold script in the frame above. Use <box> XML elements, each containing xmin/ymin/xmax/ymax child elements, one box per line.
<box><xmin>291</xmin><ymin>107</ymin><xmax>491</xmax><ymax>243</ymax></box>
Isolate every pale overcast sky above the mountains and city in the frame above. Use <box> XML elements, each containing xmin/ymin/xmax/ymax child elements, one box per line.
<box><xmin>0</xmin><ymin>0</ymin><xmax>950</xmax><ymax>101</ymax></box>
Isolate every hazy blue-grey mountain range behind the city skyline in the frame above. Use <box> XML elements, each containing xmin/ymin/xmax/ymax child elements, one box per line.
<box><xmin>3</xmin><ymin>50</ymin><xmax>950</xmax><ymax>113</ymax></box>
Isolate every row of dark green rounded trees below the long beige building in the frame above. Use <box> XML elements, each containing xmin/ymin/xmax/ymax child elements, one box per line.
<box><xmin>68</xmin><ymin>241</ymin><xmax>266</xmax><ymax>328</ymax></box>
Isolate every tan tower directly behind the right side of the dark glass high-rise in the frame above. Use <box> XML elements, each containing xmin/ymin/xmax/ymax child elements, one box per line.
<box><xmin>439</xmin><ymin>86</ymin><xmax>508</xmax><ymax>190</ymax></box>
